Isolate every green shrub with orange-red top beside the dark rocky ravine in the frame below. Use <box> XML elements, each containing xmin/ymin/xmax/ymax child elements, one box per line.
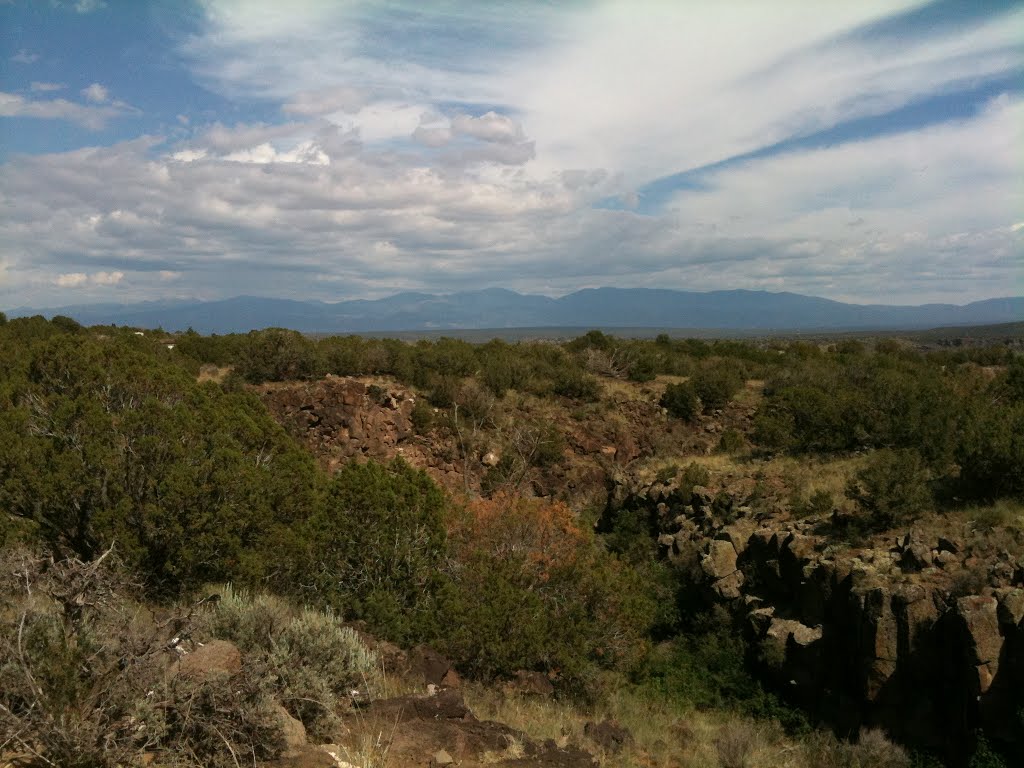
<box><xmin>436</xmin><ymin>496</ymin><xmax>657</xmax><ymax>692</ymax></box>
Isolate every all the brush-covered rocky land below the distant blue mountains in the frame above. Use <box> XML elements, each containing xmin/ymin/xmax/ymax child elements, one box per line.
<box><xmin>0</xmin><ymin>315</ymin><xmax>1024</xmax><ymax>768</ymax></box>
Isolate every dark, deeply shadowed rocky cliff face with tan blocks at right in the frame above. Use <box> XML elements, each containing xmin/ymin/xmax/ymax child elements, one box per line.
<box><xmin>609</xmin><ymin>481</ymin><xmax>1024</xmax><ymax>765</ymax></box>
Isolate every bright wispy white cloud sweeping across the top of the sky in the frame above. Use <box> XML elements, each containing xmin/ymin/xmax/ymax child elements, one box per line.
<box><xmin>183</xmin><ymin>0</ymin><xmax>1024</xmax><ymax>194</ymax></box>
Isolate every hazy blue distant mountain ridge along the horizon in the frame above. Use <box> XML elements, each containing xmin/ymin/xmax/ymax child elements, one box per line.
<box><xmin>7</xmin><ymin>288</ymin><xmax>1024</xmax><ymax>334</ymax></box>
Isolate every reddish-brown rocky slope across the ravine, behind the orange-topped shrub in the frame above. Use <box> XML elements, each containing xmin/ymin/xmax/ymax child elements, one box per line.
<box><xmin>260</xmin><ymin>376</ymin><xmax>669</xmax><ymax>507</ymax></box>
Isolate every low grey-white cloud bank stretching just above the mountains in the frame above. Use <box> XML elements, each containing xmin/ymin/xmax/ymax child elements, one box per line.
<box><xmin>0</xmin><ymin>99</ymin><xmax>1024</xmax><ymax>304</ymax></box>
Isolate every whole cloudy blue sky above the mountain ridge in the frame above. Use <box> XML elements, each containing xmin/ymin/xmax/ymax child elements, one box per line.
<box><xmin>0</xmin><ymin>0</ymin><xmax>1024</xmax><ymax>308</ymax></box>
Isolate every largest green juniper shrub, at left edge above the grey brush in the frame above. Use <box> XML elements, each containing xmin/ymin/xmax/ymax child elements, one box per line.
<box><xmin>0</xmin><ymin>331</ymin><xmax>316</xmax><ymax>597</ymax></box>
